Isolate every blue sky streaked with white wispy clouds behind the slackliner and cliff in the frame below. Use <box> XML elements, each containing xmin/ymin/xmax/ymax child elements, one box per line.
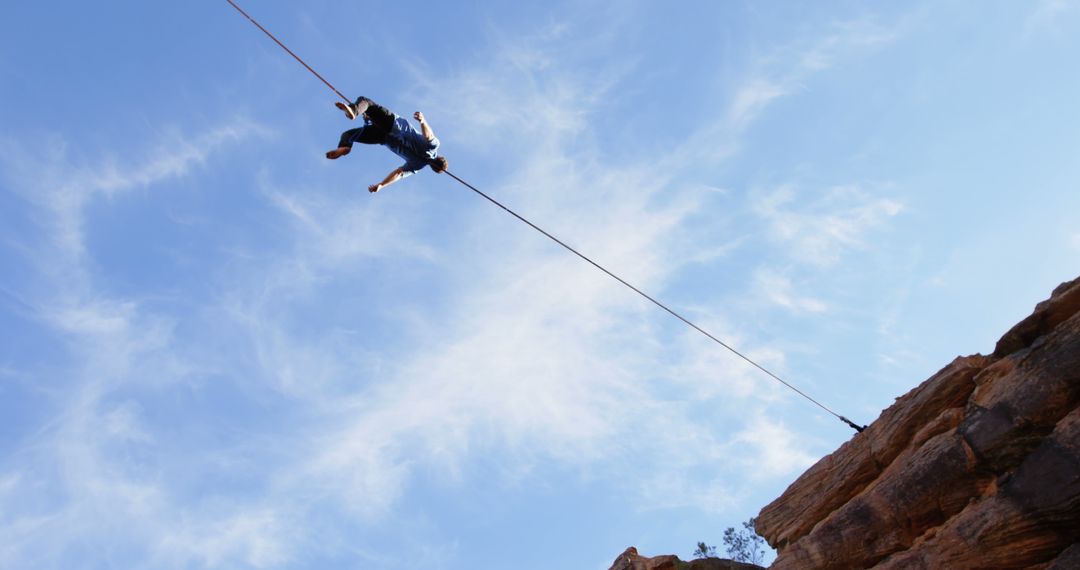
<box><xmin>0</xmin><ymin>1</ymin><xmax>1080</xmax><ymax>570</ymax></box>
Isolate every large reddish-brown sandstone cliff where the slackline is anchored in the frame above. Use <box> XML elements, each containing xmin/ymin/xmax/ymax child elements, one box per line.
<box><xmin>756</xmin><ymin>277</ymin><xmax>1080</xmax><ymax>570</ymax></box>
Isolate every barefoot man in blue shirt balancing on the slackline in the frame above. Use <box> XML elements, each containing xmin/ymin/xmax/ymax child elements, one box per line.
<box><xmin>326</xmin><ymin>97</ymin><xmax>447</xmax><ymax>193</ymax></box>
